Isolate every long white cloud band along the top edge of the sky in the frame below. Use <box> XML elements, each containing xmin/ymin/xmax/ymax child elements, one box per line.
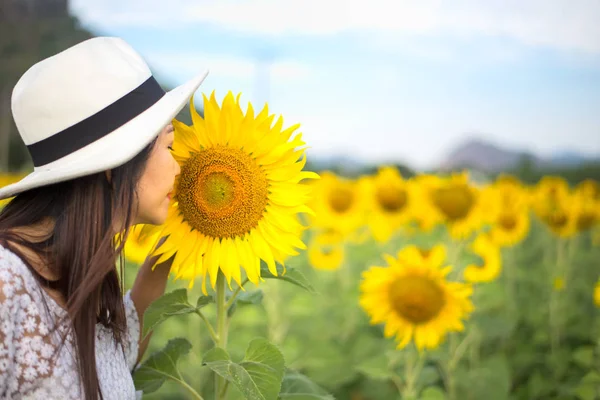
<box><xmin>72</xmin><ymin>0</ymin><xmax>600</xmax><ymax>53</ymax></box>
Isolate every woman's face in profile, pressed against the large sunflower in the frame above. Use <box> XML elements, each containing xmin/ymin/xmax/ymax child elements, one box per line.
<box><xmin>135</xmin><ymin>124</ymin><xmax>180</xmax><ymax>225</ymax></box>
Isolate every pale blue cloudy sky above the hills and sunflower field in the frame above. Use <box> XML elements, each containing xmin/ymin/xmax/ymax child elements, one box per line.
<box><xmin>70</xmin><ymin>0</ymin><xmax>600</xmax><ymax>169</ymax></box>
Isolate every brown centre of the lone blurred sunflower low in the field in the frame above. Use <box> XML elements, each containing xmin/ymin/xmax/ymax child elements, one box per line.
<box><xmin>389</xmin><ymin>276</ymin><xmax>445</xmax><ymax>324</ymax></box>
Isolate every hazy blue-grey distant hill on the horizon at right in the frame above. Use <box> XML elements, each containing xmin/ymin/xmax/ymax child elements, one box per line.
<box><xmin>438</xmin><ymin>139</ymin><xmax>600</xmax><ymax>172</ymax></box>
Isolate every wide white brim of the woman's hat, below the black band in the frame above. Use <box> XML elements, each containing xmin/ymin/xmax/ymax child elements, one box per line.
<box><xmin>0</xmin><ymin>71</ymin><xmax>208</xmax><ymax>200</ymax></box>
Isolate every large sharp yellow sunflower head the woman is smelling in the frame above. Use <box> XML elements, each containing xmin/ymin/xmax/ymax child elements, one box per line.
<box><xmin>147</xmin><ymin>92</ymin><xmax>318</xmax><ymax>291</ymax></box>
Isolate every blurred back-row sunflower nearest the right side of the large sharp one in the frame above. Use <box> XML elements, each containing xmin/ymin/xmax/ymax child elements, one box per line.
<box><xmin>310</xmin><ymin>171</ymin><xmax>366</xmax><ymax>237</ymax></box>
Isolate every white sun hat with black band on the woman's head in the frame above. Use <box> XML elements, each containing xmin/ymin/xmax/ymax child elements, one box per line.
<box><xmin>0</xmin><ymin>37</ymin><xmax>208</xmax><ymax>199</ymax></box>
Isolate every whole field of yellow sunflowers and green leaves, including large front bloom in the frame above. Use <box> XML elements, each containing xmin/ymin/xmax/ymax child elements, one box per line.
<box><xmin>1</xmin><ymin>94</ymin><xmax>600</xmax><ymax>400</ymax></box>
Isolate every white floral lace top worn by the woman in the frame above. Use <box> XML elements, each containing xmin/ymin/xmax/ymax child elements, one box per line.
<box><xmin>0</xmin><ymin>246</ymin><xmax>141</xmax><ymax>400</ymax></box>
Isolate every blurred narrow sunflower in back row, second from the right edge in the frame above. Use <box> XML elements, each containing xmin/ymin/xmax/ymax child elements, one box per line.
<box><xmin>531</xmin><ymin>176</ymin><xmax>577</xmax><ymax>238</ymax></box>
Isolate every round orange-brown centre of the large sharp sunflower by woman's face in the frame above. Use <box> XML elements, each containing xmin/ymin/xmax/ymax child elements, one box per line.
<box><xmin>177</xmin><ymin>146</ymin><xmax>269</xmax><ymax>238</ymax></box>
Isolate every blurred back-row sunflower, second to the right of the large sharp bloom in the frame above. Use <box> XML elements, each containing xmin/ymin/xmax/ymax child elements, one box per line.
<box><xmin>366</xmin><ymin>167</ymin><xmax>414</xmax><ymax>242</ymax></box>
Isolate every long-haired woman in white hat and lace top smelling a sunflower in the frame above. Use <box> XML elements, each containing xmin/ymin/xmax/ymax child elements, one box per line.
<box><xmin>0</xmin><ymin>38</ymin><xmax>206</xmax><ymax>400</ymax></box>
